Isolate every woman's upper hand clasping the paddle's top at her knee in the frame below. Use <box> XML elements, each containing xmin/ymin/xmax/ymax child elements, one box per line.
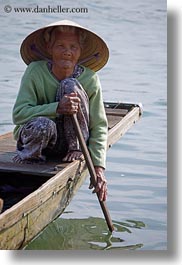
<box><xmin>57</xmin><ymin>92</ymin><xmax>80</xmax><ymax>115</ymax></box>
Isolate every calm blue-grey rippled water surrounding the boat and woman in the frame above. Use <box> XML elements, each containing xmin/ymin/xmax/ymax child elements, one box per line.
<box><xmin>0</xmin><ymin>0</ymin><xmax>167</xmax><ymax>250</ymax></box>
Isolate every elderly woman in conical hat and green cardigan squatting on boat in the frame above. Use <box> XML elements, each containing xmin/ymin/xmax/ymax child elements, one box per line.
<box><xmin>13</xmin><ymin>20</ymin><xmax>108</xmax><ymax>200</ymax></box>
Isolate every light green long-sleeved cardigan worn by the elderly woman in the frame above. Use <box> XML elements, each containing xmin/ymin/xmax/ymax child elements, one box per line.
<box><xmin>13</xmin><ymin>61</ymin><xmax>107</xmax><ymax>168</ymax></box>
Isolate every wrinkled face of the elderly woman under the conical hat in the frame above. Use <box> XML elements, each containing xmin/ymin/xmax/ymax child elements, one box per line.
<box><xmin>48</xmin><ymin>32</ymin><xmax>81</xmax><ymax>70</ymax></box>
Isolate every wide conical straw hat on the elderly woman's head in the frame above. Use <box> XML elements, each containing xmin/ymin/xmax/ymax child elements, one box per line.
<box><xmin>20</xmin><ymin>20</ymin><xmax>109</xmax><ymax>72</ymax></box>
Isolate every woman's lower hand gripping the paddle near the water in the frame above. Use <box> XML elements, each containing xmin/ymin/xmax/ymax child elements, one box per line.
<box><xmin>89</xmin><ymin>167</ymin><xmax>107</xmax><ymax>201</ymax></box>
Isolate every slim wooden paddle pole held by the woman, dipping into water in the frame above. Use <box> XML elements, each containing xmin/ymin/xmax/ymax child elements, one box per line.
<box><xmin>72</xmin><ymin>114</ymin><xmax>114</xmax><ymax>232</ymax></box>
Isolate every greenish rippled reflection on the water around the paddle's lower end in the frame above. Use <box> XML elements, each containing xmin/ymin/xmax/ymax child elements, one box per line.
<box><xmin>25</xmin><ymin>217</ymin><xmax>145</xmax><ymax>250</ymax></box>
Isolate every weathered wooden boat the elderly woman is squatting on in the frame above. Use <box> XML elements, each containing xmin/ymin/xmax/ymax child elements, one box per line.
<box><xmin>0</xmin><ymin>103</ymin><xmax>142</xmax><ymax>249</ymax></box>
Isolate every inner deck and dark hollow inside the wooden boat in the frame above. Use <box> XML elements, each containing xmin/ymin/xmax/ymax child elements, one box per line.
<box><xmin>0</xmin><ymin>103</ymin><xmax>135</xmax><ymax>212</ymax></box>
